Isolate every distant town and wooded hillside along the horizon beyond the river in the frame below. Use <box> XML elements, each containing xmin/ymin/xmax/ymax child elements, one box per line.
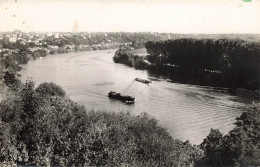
<box><xmin>0</xmin><ymin>30</ymin><xmax>260</xmax><ymax>56</ymax></box>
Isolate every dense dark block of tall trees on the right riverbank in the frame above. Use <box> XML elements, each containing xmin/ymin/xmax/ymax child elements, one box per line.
<box><xmin>145</xmin><ymin>39</ymin><xmax>260</xmax><ymax>90</ymax></box>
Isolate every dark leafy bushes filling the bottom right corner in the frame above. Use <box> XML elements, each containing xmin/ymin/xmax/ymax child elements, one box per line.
<box><xmin>197</xmin><ymin>104</ymin><xmax>260</xmax><ymax>166</ymax></box>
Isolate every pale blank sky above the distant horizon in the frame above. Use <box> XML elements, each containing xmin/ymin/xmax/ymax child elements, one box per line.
<box><xmin>0</xmin><ymin>0</ymin><xmax>260</xmax><ymax>34</ymax></box>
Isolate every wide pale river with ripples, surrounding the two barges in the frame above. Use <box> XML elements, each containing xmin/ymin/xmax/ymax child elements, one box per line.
<box><xmin>21</xmin><ymin>50</ymin><xmax>245</xmax><ymax>144</ymax></box>
